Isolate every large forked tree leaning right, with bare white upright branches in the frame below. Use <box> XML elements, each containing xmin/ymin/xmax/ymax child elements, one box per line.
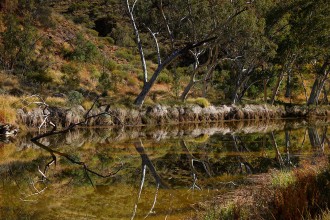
<box><xmin>126</xmin><ymin>0</ymin><xmax>215</xmax><ymax>106</ymax></box>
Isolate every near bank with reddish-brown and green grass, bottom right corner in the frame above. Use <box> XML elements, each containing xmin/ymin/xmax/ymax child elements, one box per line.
<box><xmin>196</xmin><ymin>156</ymin><xmax>330</xmax><ymax>220</ymax></box>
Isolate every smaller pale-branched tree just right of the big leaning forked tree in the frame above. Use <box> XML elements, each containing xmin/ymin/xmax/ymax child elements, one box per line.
<box><xmin>181</xmin><ymin>0</ymin><xmax>250</xmax><ymax>101</ymax></box>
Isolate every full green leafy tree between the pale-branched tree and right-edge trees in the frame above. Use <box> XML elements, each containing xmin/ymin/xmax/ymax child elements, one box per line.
<box><xmin>217</xmin><ymin>5</ymin><xmax>276</xmax><ymax>104</ymax></box>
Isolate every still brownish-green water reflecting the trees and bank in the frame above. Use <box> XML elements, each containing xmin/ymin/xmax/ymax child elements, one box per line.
<box><xmin>0</xmin><ymin>121</ymin><xmax>330</xmax><ymax>219</ymax></box>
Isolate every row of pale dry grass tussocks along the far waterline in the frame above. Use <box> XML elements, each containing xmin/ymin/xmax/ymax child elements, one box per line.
<box><xmin>17</xmin><ymin>105</ymin><xmax>330</xmax><ymax>127</ymax></box>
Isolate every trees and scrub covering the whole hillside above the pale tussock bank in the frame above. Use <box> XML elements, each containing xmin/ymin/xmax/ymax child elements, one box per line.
<box><xmin>0</xmin><ymin>0</ymin><xmax>330</xmax><ymax>107</ymax></box>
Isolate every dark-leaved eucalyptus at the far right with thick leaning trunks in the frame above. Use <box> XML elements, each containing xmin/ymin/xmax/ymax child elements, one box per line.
<box><xmin>267</xmin><ymin>0</ymin><xmax>330</xmax><ymax>104</ymax></box>
